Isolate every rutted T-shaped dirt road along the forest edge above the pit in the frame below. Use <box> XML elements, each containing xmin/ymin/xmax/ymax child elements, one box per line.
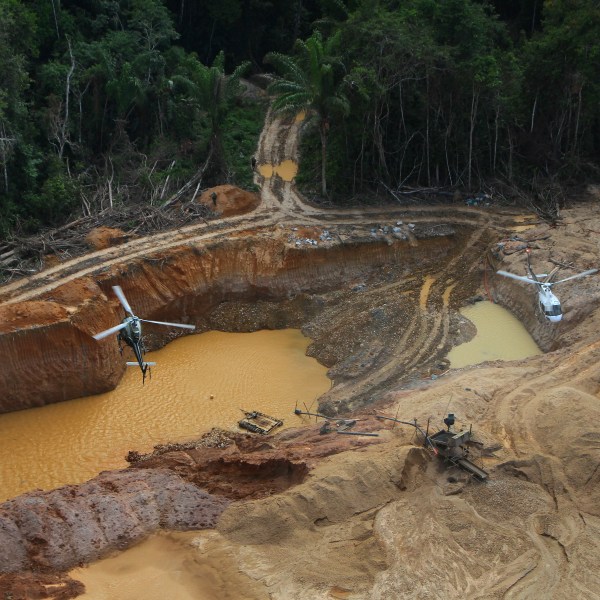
<box><xmin>0</xmin><ymin>106</ymin><xmax>520</xmax><ymax>303</ymax></box>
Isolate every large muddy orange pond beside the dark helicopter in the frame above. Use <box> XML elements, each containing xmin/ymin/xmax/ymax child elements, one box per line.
<box><xmin>0</xmin><ymin>329</ymin><xmax>331</xmax><ymax>501</ymax></box>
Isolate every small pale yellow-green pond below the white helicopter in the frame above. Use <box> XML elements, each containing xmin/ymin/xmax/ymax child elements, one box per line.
<box><xmin>448</xmin><ymin>301</ymin><xmax>542</xmax><ymax>369</ymax></box>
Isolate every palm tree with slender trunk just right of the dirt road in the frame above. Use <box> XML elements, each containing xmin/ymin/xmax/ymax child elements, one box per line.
<box><xmin>265</xmin><ymin>31</ymin><xmax>350</xmax><ymax>197</ymax></box>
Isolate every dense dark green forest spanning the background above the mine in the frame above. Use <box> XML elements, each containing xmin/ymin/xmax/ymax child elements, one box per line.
<box><xmin>0</xmin><ymin>0</ymin><xmax>600</xmax><ymax>235</ymax></box>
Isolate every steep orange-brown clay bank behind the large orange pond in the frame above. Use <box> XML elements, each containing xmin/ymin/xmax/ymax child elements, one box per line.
<box><xmin>0</xmin><ymin>224</ymin><xmax>464</xmax><ymax>412</ymax></box>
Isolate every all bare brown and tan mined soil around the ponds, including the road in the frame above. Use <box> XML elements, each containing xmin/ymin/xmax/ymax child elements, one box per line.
<box><xmin>0</xmin><ymin>109</ymin><xmax>600</xmax><ymax>600</ymax></box>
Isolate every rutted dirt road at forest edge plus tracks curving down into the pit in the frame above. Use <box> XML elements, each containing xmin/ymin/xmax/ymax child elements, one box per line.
<box><xmin>0</xmin><ymin>110</ymin><xmax>518</xmax><ymax>418</ymax></box>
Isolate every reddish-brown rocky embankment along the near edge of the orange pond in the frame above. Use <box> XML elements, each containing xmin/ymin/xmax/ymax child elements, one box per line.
<box><xmin>0</xmin><ymin>419</ymin><xmax>379</xmax><ymax>576</ymax></box>
